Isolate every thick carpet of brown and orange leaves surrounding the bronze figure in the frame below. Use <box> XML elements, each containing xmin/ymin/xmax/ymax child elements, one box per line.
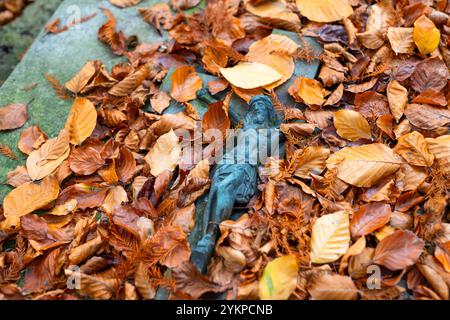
<box><xmin>0</xmin><ymin>0</ymin><xmax>450</xmax><ymax>299</ymax></box>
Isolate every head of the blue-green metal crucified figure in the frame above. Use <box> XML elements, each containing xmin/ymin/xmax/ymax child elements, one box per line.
<box><xmin>244</xmin><ymin>94</ymin><xmax>277</xmax><ymax>128</ymax></box>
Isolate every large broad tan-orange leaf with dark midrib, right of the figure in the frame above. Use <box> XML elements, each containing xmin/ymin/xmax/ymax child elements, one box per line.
<box><xmin>327</xmin><ymin>143</ymin><xmax>403</xmax><ymax>187</ymax></box>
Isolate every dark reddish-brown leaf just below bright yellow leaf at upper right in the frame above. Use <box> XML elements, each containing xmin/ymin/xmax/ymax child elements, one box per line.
<box><xmin>411</xmin><ymin>58</ymin><xmax>449</xmax><ymax>92</ymax></box>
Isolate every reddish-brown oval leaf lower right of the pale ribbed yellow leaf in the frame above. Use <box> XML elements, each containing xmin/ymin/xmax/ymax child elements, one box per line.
<box><xmin>373</xmin><ymin>230</ymin><xmax>424</xmax><ymax>270</ymax></box>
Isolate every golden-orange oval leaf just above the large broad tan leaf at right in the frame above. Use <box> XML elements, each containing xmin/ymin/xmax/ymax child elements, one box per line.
<box><xmin>334</xmin><ymin>110</ymin><xmax>372</xmax><ymax>141</ymax></box>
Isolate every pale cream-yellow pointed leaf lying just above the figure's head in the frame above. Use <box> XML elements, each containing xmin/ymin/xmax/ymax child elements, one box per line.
<box><xmin>219</xmin><ymin>62</ymin><xmax>282</xmax><ymax>89</ymax></box>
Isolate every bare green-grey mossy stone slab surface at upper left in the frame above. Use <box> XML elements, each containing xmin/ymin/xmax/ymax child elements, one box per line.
<box><xmin>0</xmin><ymin>0</ymin><xmax>176</xmax><ymax>201</ymax></box>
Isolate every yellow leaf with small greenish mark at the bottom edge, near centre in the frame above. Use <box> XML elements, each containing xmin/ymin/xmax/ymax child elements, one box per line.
<box><xmin>259</xmin><ymin>255</ymin><xmax>298</xmax><ymax>300</ymax></box>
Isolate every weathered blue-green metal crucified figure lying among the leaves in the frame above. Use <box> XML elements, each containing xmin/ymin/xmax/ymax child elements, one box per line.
<box><xmin>191</xmin><ymin>95</ymin><xmax>279</xmax><ymax>273</ymax></box>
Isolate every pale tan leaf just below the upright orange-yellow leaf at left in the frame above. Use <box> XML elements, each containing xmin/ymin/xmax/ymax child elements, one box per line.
<box><xmin>27</xmin><ymin>129</ymin><xmax>70</xmax><ymax>180</ymax></box>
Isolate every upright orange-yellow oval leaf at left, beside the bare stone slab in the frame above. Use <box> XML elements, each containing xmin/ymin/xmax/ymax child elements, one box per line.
<box><xmin>65</xmin><ymin>98</ymin><xmax>97</xmax><ymax>145</ymax></box>
